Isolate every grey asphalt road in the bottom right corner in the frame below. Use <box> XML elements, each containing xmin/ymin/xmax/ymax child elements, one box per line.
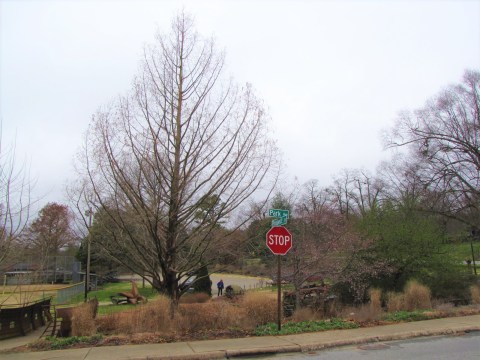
<box><xmin>252</xmin><ymin>331</ymin><xmax>480</xmax><ymax>360</ymax></box>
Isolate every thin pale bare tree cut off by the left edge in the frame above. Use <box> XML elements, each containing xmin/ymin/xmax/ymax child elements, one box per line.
<box><xmin>0</xmin><ymin>131</ymin><xmax>32</xmax><ymax>265</ymax></box>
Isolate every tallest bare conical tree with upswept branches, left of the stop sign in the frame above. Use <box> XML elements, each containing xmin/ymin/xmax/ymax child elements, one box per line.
<box><xmin>77</xmin><ymin>14</ymin><xmax>278</xmax><ymax>305</ymax></box>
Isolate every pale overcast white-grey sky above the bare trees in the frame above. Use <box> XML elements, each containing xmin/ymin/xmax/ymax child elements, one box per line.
<box><xmin>0</xmin><ymin>0</ymin><xmax>480</xmax><ymax>206</ymax></box>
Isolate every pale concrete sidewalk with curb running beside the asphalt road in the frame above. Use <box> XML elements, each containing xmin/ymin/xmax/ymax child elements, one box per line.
<box><xmin>0</xmin><ymin>315</ymin><xmax>480</xmax><ymax>360</ymax></box>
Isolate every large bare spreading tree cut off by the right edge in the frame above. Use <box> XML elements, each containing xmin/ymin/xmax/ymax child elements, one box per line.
<box><xmin>386</xmin><ymin>71</ymin><xmax>480</xmax><ymax>229</ymax></box>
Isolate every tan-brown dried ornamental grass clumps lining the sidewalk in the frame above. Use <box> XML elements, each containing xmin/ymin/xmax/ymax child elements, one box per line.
<box><xmin>90</xmin><ymin>283</ymin><xmax>478</xmax><ymax>343</ymax></box>
